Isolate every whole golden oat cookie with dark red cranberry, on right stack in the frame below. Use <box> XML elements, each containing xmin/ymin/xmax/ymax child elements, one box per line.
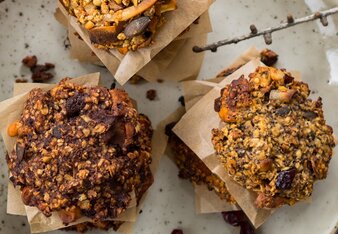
<box><xmin>212</xmin><ymin>67</ymin><xmax>335</xmax><ymax>208</ymax></box>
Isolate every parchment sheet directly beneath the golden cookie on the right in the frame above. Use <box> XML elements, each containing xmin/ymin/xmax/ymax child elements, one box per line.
<box><xmin>173</xmin><ymin>59</ymin><xmax>273</xmax><ymax>228</ymax></box>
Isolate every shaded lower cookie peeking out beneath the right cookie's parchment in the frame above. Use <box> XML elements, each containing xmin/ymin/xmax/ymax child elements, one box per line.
<box><xmin>166</xmin><ymin>123</ymin><xmax>236</xmax><ymax>203</ymax></box>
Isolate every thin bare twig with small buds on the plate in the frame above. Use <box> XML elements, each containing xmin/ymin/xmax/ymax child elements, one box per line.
<box><xmin>193</xmin><ymin>7</ymin><xmax>338</xmax><ymax>53</ymax></box>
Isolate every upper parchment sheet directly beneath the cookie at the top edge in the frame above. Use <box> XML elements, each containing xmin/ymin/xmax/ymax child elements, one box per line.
<box><xmin>58</xmin><ymin>0</ymin><xmax>212</xmax><ymax>85</ymax></box>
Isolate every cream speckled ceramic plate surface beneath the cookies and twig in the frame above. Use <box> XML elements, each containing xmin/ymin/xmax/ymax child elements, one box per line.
<box><xmin>0</xmin><ymin>0</ymin><xmax>338</xmax><ymax>234</ymax></box>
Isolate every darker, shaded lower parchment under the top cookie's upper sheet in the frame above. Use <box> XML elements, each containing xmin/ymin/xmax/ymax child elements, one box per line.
<box><xmin>54</xmin><ymin>8</ymin><xmax>212</xmax><ymax>82</ymax></box>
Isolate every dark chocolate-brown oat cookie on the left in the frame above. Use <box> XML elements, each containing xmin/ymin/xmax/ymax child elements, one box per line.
<box><xmin>7</xmin><ymin>79</ymin><xmax>153</xmax><ymax>224</ymax></box>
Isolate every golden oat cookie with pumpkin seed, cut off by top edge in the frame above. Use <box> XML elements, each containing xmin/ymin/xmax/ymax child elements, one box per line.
<box><xmin>61</xmin><ymin>0</ymin><xmax>176</xmax><ymax>54</ymax></box>
